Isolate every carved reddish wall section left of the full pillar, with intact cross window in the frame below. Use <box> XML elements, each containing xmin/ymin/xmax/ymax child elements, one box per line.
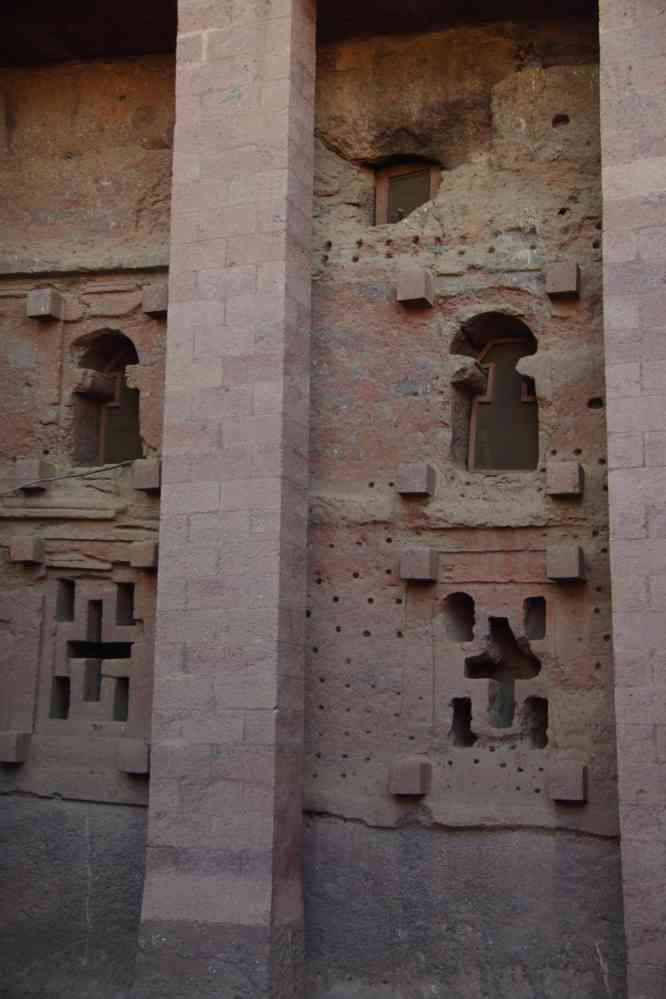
<box><xmin>0</xmin><ymin>272</ymin><xmax>165</xmax><ymax>804</ymax></box>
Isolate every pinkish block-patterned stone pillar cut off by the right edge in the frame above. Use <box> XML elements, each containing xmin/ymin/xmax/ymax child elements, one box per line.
<box><xmin>601</xmin><ymin>0</ymin><xmax>666</xmax><ymax>999</ymax></box>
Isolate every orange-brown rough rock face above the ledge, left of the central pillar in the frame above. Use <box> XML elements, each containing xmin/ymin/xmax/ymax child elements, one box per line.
<box><xmin>0</xmin><ymin>55</ymin><xmax>175</xmax><ymax>273</ymax></box>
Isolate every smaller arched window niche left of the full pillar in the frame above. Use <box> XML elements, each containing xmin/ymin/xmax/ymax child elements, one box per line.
<box><xmin>72</xmin><ymin>330</ymin><xmax>143</xmax><ymax>465</ymax></box>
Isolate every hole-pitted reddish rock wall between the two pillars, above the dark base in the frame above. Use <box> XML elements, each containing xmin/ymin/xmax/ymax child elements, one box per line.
<box><xmin>306</xmin><ymin>13</ymin><xmax>620</xmax><ymax>999</ymax></box>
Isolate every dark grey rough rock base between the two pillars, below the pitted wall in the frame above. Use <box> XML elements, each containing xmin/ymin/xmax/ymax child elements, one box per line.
<box><xmin>305</xmin><ymin>817</ymin><xmax>624</xmax><ymax>999</ymax></box>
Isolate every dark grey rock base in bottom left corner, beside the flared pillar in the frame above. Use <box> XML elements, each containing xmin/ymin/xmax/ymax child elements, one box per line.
<box><xmin>0</xmin><ymin>797</ymin><xmax>146</xmax><ymax>999</ymax></box>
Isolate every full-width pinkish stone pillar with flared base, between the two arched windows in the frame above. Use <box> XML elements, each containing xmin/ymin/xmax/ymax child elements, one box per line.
<box><xmin>135</xmin><ymin>0</ymin><xmax>315</xmax><ymax>999</ymax></box>
